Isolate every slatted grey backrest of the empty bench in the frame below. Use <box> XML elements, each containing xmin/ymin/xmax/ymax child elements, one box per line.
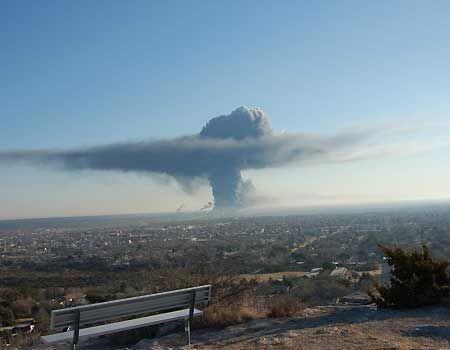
<box><xmin>50</xmin><ymin>285</ymin><xmax>211</xmax><ymax>329</ymax></box>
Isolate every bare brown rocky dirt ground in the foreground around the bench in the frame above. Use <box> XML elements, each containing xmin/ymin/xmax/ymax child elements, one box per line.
<box><xmin>32</xmin><ymin>306</ymin><xmax>450</xmax><ymax>350</ymax></box>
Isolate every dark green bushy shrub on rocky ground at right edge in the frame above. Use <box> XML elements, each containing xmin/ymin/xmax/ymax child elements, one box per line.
<box><xmin>371</xmin><ymin>245</ymin><xmax>450</xmax><ymax>308</ymax></box>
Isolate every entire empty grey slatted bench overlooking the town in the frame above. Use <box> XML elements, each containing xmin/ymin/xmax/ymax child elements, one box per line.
<box><xmin>42</xmin><ymin>285</ymin><xmax>211</xmax><ymax>349</ymax></box>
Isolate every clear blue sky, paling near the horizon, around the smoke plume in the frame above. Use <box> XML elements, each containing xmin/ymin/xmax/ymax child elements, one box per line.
<box><xmin>0</xmin><ymin>0</ymin><xmax>450</xmax><ymax>218</ymax></box>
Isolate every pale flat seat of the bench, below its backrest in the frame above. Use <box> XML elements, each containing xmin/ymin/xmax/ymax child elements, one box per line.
<box><xmin>42</xmin><ymin>309</ymin><xmax>202</xmax><ymax>344</ymax></box>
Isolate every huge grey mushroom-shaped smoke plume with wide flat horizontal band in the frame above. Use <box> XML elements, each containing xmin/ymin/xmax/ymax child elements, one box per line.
<box><xmin>0</xmin><ymin>107</ymin><xmax>380</xmax><ymax>208</ymax></box>
